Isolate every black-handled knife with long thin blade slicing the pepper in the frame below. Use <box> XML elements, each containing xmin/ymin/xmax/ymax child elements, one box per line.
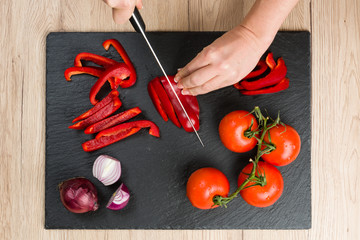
<box><xmin>130</xmin><ymin>8</ymin><xmax>204</xmax><ymax>147</ymax></box>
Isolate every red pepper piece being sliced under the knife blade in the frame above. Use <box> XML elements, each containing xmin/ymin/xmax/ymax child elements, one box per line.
<box><xmin>148</xmin><ymin>76</ymin><xmax>200</xmax><ymax>132</ymax></box>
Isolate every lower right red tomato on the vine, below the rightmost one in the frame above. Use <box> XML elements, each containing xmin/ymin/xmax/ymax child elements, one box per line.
<box><xmin>238</xmin><ymin>162</ymin><xmax>284</xmax><ymax>207</ymax></box>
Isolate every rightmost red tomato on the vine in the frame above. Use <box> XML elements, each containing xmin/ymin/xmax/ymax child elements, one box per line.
<box><xmin>261</xmin><ymin>125</ymin><xmax>301</xmax><ymax>166</ymax></box>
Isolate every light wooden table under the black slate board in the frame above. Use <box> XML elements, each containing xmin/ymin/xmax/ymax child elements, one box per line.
<box><xmin>0</xmin><ymin>0</ymin><xmax>360</xmax><ymax>240</ymax></box>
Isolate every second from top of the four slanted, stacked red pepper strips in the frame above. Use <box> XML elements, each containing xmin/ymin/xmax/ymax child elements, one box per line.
<box><xmin>69</xmin><ymin>97</ymin><xmax>122</xmax><ymax>129</ymax></box>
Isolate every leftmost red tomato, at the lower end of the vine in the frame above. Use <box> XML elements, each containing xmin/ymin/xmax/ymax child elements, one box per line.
<box><xmin>186</xmin><ymin>167</ymin><xmax>230</xmax><ymax>209</ymax></box>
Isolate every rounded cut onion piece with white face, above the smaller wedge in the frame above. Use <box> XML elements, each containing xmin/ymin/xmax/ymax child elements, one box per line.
<box><xmin>93</xmin><ymin>155</ymin><xmax>121</xmax><ymax>186</ymax></box>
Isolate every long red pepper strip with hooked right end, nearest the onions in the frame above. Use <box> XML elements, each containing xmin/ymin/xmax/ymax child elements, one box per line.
<box><xmin>82</xmin><ymin>120</ymin><xmax>160</xmax><ymax>152</ymax></box>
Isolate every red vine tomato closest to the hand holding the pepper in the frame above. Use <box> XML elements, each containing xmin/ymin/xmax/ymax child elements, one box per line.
<box><xmin>219</xmin><ymin>110</ymin><xmax>258</xmax><ymax>153</ymax></box>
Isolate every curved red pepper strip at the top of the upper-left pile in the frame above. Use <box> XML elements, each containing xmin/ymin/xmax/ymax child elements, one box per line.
<box><xmin>103</xmin><ymin>39</ymin><xmax>136</xmax><ymax>88</ymax></box>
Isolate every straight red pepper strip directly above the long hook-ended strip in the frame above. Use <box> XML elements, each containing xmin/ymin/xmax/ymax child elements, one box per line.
<box><xmin>85</xmin><ymin>107</ymin><xmax>141</xmax><ymax>134</ymax></box>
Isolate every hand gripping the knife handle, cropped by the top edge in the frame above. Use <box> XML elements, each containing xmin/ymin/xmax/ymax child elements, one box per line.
<box><xmin>103</xmin><ymin>0</ymin><xmax>142</xmax><ymax>24</ymax></box>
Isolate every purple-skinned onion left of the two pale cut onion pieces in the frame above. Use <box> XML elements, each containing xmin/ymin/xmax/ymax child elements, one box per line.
<box><xmin>59</xmin><ymin>177</ymin><xmax>99</xmax><ymax>213</ymax></box>
